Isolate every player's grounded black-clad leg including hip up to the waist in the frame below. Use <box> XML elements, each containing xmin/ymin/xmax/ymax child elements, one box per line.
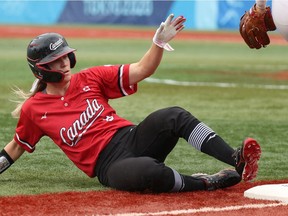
<box><xmin>95</xmin><ymin>132</ymin><xmax>241</xmax><ymax>192</ymax></box>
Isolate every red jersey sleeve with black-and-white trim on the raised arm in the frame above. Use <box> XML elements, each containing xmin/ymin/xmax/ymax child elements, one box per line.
<box><xmin>86</xmin><ymin>64</ymin><xmax>137</xmax><ymax>99</ymax></box>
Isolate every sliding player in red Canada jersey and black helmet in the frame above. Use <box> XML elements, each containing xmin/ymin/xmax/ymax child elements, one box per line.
<box><xmin>0</xmin><ymin>15</ymin><xmax>261</xmax><ymax>193</ymax></box>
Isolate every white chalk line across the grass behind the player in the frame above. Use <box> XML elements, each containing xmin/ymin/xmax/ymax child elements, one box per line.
<box><xmin>145</xmin><ymin>77</ymin><xmax>288</xmax><ymax>90</ymax></box>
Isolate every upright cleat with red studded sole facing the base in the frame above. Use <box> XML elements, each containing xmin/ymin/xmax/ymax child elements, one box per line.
<box><xmin>233</xmin><ymin>138</ymin><xmax>261</xmax><ymax>181</ymax></box>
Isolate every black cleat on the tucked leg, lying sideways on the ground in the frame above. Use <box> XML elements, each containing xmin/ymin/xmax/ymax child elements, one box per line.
<box><xmin>192</xmin><ymin>169</ymin><xmax>241</xmax><ymax>191</ymax></box>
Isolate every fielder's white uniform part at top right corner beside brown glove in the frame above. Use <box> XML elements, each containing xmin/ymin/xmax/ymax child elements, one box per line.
<box><xmin>272</xmin><ymin>0</ymin><xmax>288</xmax><ymax>41</ymax></box>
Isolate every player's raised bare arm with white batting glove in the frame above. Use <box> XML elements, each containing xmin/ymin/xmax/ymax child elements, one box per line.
<box><xmin>129</xmin><ymin>14</ymin><xmax>186</xmax><ymax>85</ymax></box>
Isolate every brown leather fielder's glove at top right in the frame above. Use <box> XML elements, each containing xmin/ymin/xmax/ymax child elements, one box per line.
<box><xmin>239</xmin><ymin>4</ymin><xmax>276</xmax><ymax>49</ymax></box>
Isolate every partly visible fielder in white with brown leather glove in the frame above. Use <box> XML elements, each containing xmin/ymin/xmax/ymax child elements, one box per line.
<box><xmin>240</xmin><ymin>0</ymin><xmax>288</xmax><ymax>49</ymax></box>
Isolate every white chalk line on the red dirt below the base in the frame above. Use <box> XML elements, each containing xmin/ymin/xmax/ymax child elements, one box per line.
<box><xmin>111</xmin><ymin>203</ymin><xmax>288</xmax><ymax>216</ymax></box>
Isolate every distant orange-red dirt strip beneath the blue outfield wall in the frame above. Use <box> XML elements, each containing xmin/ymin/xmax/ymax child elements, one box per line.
<box><xmin>0</xmin><ymin>26</ymin><xmax>287</xmax><ymax>44</ymax></box>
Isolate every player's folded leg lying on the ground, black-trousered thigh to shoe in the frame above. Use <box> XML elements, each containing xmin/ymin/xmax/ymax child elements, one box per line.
<box><xmin>107</xmin><ymin>157</ymin><xmax>241</xmax><ymax>193</ymax></box>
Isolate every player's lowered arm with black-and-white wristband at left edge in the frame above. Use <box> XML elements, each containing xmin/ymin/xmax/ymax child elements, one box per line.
<box><xmin>0</xmin><ymin>139</ymin><xmax>25</xmax><ymax>173</ymax></box>
